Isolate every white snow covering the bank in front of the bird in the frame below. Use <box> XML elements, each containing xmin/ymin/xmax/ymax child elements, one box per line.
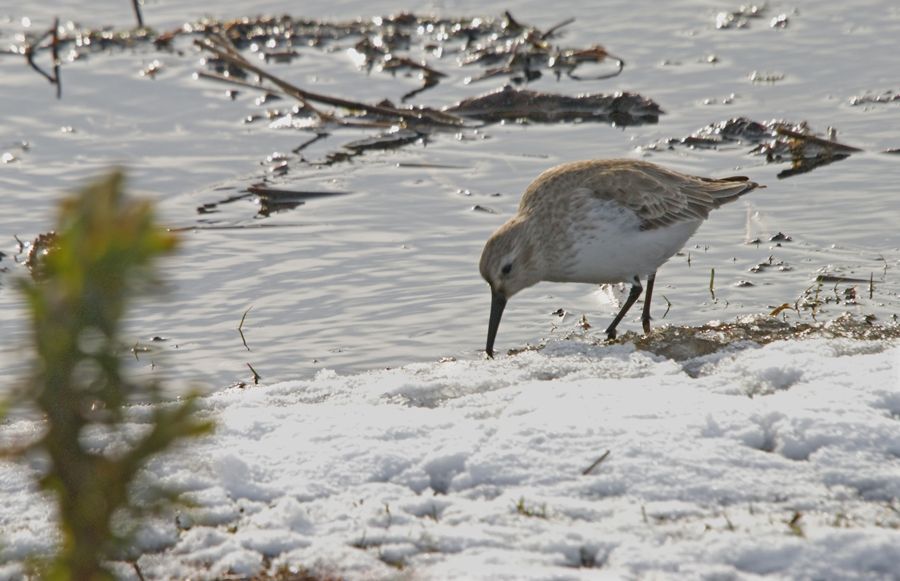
<box><xmin>0</xmin><ymin>339</ymin><xmax>900</xmax><ymax>580</ymax></box>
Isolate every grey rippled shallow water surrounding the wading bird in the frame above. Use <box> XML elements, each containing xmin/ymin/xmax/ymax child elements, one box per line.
<box><xmin>0</xmin><ymin>0</ymin><xmax>900</xmax><ymax>388</ymax></box>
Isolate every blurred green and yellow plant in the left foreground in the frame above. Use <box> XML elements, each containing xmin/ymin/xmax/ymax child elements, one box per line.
<box><xmin>15</xmin><ymin>172</ymin><xmax>211</xmax><ymax>581</ymax></box>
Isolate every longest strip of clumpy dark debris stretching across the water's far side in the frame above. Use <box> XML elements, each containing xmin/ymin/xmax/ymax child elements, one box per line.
<box><xmin>9</xmin><ymin>12</ymin><xmax>625</xmax><ymax>101</ymax></box>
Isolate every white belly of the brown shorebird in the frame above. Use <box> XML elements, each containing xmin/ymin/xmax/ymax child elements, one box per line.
<box><xmin>560</xmin><ymin>214</ymin><xmax>701</xmax><ymax>284</ymax></box>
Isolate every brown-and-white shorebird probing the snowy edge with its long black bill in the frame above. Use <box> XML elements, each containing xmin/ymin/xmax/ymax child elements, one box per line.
<box><xmin>479</xmin><ymin>159</ymin><xmax>765</xmax><ymax>357</ymax></box>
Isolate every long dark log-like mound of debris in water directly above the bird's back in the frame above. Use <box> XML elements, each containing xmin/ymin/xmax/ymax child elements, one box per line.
<box><xmin>444</xmin><ymin>85</ymin><xmax>663</xmax><ymax>125</ymax></box>
